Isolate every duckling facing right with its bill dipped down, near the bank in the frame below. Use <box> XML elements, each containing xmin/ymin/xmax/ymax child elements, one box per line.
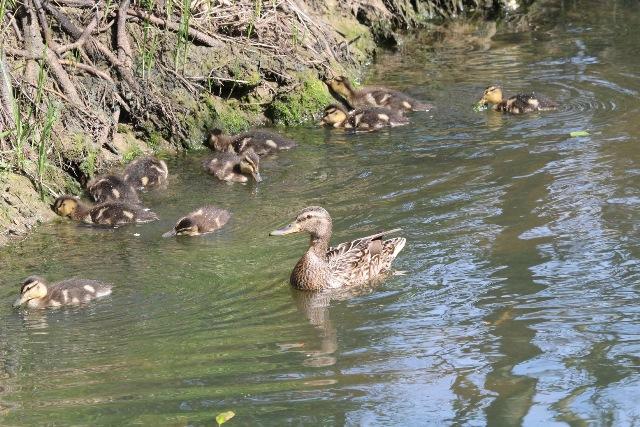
<box><xmin>203</xmin><ymin>148</ymin><xmax>262</xmax><ymax>182</ymax></box>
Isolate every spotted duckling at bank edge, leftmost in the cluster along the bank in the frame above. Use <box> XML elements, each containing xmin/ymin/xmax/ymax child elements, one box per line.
<box><xmin>53</xmin><ymin>196</ymin><xmax>158</xmax><ymax>227</ymax></box>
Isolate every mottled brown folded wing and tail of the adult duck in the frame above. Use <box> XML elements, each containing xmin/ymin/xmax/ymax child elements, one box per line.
<box><xmin>327</xmin><ymin>228</ymin><xmax>406</xmax><ymax>285</ymax></box>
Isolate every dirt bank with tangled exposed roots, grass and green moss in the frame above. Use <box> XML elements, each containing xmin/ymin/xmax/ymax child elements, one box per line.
<box><xmin>0</xmin><ymin>0</ymin><xmax>532</xmax><ymax>245</ymax></box>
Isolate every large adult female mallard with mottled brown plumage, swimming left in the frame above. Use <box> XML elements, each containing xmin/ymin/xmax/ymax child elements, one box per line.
<box><xmin>270</xmin><ymin>206</ymin><xmax>406</xmax><ymax>291</ymax></box>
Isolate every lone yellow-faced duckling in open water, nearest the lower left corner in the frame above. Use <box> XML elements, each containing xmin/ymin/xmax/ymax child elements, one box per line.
<box><xmin>13</xmin><ymin>276</ymin><xmax>111</xmax><ymax>308</ymax></box>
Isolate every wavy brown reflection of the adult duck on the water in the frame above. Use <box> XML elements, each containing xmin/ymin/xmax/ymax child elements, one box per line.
<box><xmin>291</xmin><ymin>280</ymin><xmax>382</xmax><ymax>367</ymax></box>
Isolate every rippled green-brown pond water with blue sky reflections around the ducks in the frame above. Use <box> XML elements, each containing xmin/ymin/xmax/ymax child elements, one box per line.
<box><xmin>0</xmin><ymin>1</ymin><xmax>640</xmax><ymax>425</ymax></box>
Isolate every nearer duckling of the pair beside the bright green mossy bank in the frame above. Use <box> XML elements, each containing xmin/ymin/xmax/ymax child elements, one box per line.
<box><xmin>322</xmin><ymin>104</ymin><xmax>409</xmax><ymax>132</ymax></box>
